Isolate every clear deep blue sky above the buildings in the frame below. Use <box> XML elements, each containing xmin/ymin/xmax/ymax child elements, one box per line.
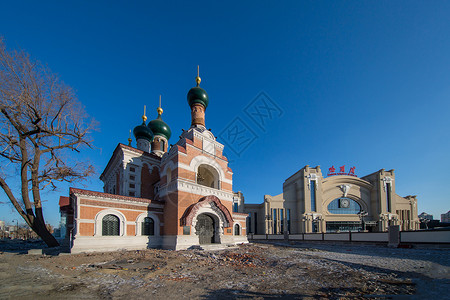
<box><xmin>0</xmin><ymin>0</ymin><xmax>450</xmax><ymax>225</ymax></box>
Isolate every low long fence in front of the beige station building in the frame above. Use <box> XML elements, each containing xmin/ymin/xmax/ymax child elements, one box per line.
<box><xmin>248</xmin><ymin>230</ymin><xmax>450</xmax><ymax>244</ymax></box>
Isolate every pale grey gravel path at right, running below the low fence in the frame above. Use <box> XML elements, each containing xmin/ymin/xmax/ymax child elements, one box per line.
<box><xmin>268</xmin><ymin>243</ymin><xmax>450</xmax><ymax>299</ymax></box>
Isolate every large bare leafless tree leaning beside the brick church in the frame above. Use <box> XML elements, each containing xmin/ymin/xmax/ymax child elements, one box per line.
<box><xmin>0</xmin><ymin>38</ymin><xmax>94</xmax><ymax>247</ymax></box>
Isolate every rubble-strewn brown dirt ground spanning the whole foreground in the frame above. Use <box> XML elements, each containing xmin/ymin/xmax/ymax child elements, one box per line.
<box><xmin>0</xmin><ymin>242</ymin><xmax>450</xmax><ymax>299</ymax></box>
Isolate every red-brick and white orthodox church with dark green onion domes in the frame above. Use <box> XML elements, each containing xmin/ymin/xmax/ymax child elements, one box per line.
<box><xmin>60</xmin><ymin>69</ymin><xmax>248</xmax><ymax>253</ymax></box>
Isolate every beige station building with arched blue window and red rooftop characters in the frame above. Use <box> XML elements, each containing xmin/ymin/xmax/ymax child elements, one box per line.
<box><xmin>244</xmin><ymin>166</ymin><xmax>419</xmax><ymax>234</ymax></box>
